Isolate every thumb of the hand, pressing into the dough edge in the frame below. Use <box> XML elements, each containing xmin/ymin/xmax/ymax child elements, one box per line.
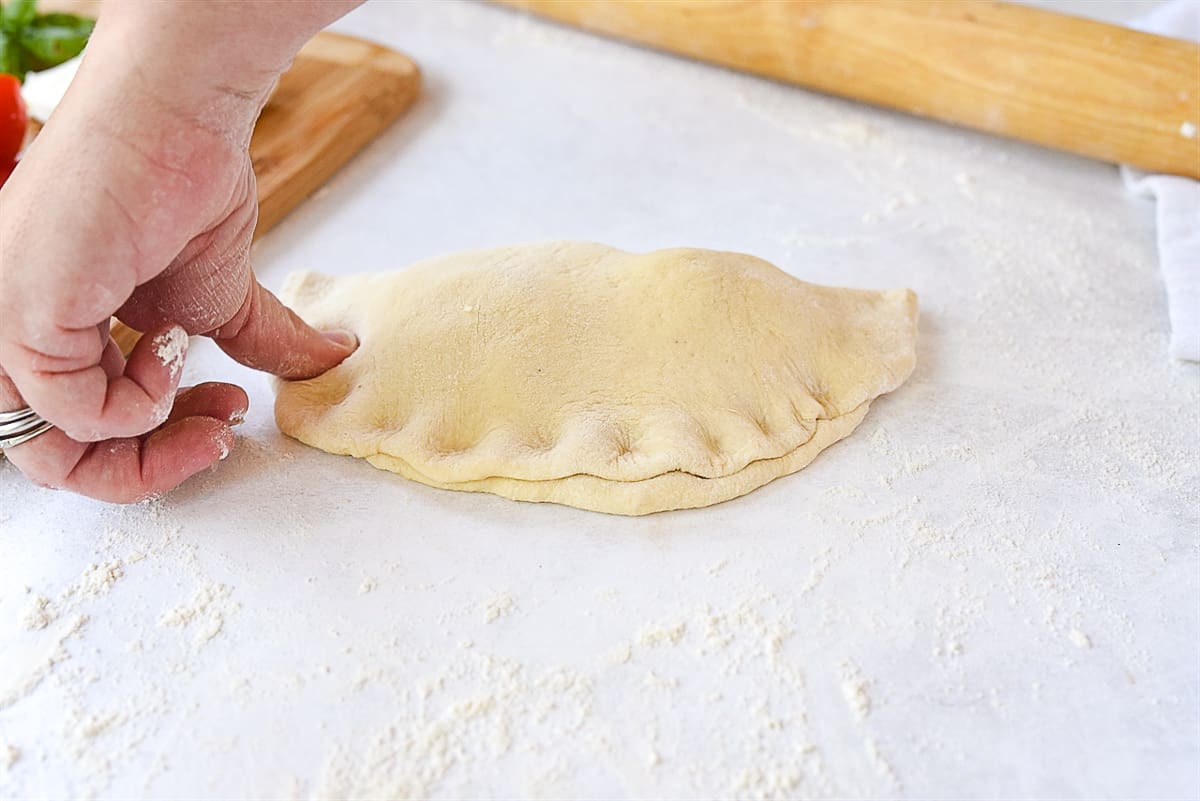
<box><xmin>208</xmin><ymin>272</ymin><xmax>359</xmax><ymax>379</ymax></box>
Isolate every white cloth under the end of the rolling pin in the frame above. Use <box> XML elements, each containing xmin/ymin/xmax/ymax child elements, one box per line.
<box><xmin>1121</xmin><ymin>0</ymin><xmax>1200</xmax><ymax>361</ymax></box>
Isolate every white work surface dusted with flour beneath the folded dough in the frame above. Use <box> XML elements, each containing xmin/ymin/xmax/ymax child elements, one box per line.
<box><xmin>0</xmin><ymin>1</ymin><xmax>1200</xmax><ymax>799</ymax></box>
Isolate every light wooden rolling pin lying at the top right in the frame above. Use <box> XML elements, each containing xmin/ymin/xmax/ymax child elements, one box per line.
<box><xmin>497</xmin><ymin>0</ymin><xmax>1200</xmax><ymax>177</ymax></box>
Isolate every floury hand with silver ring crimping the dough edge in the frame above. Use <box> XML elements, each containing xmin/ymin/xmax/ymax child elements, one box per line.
<box><xmin>0</xmin><ymin>2</ymin><xmax>355</xmax><ymax>502</ymax></box>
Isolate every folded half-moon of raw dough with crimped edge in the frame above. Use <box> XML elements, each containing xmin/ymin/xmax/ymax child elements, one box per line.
<box><xmin>275</xmin><ymin>242</ymin><xmax>917</xmax><ymax>514</ymax></box>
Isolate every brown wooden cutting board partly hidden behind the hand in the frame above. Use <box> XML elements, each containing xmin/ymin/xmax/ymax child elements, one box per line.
<box><xmin>31</xmin><ymin>0</ymin><xmax>421</xmax><ymax>351</ymax></box>
